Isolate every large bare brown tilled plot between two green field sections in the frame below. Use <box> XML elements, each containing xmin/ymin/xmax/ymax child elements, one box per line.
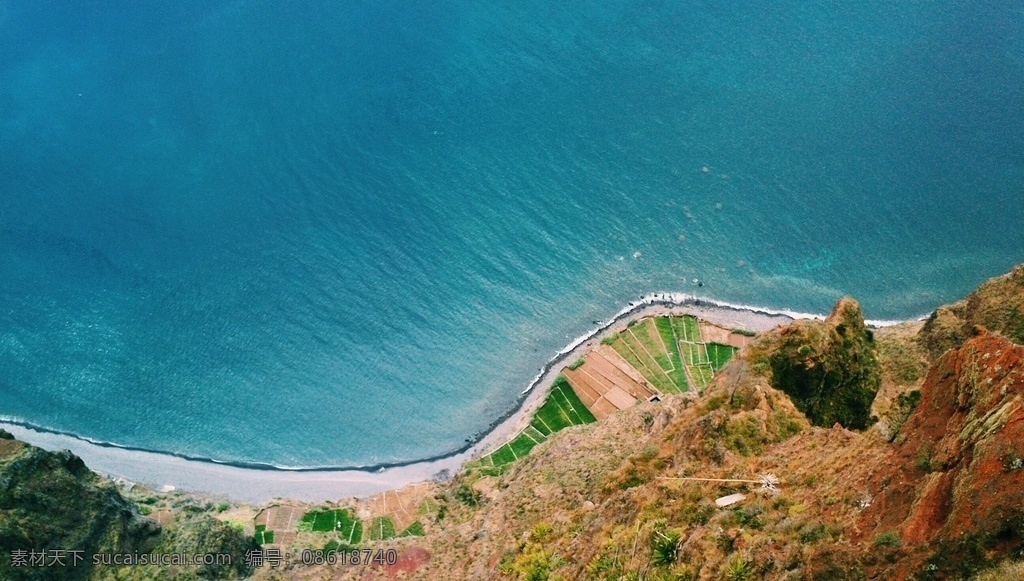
<box><xmin>562</xmin><ymin>345</ymin><xmax>657</xmax><ymax>419</ymax></box>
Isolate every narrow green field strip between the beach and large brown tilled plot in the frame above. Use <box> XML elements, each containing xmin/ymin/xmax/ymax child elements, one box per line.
<box><xmin>468</xmin><ymin>375</ymin><xmax>597</xmax><ymax>474</ymax></box>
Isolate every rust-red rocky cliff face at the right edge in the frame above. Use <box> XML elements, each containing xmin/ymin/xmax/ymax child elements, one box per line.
<box><xmin>858</xmin><ymin>329</ymin><xmax>1024</xmax><ymax>579</ymax></box>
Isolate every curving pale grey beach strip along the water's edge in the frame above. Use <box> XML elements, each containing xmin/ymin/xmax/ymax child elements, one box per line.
<box><xmin>0</xmin><ymin>292</ymin><xmax>900</xmax><ymax>503</ymax></box>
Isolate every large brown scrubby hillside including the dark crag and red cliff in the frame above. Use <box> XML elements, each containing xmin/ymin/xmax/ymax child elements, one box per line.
<box><xmin>395</xmin><ymin>267</ymin><xmax>1024</xmax><ymax>580</ymax></box>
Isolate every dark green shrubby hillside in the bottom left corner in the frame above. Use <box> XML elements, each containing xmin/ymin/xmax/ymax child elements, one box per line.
<box><xmin>0</xmin><ymin>430</ymin><xmax>256</xmax><ymax>580</ymax></box>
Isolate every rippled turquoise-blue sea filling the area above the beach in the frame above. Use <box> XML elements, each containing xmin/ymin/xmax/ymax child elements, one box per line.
<box><xmin>0</xmin><ymin>0</ymin><xmax>1024</xmax><ymax>466</ymax></box>
